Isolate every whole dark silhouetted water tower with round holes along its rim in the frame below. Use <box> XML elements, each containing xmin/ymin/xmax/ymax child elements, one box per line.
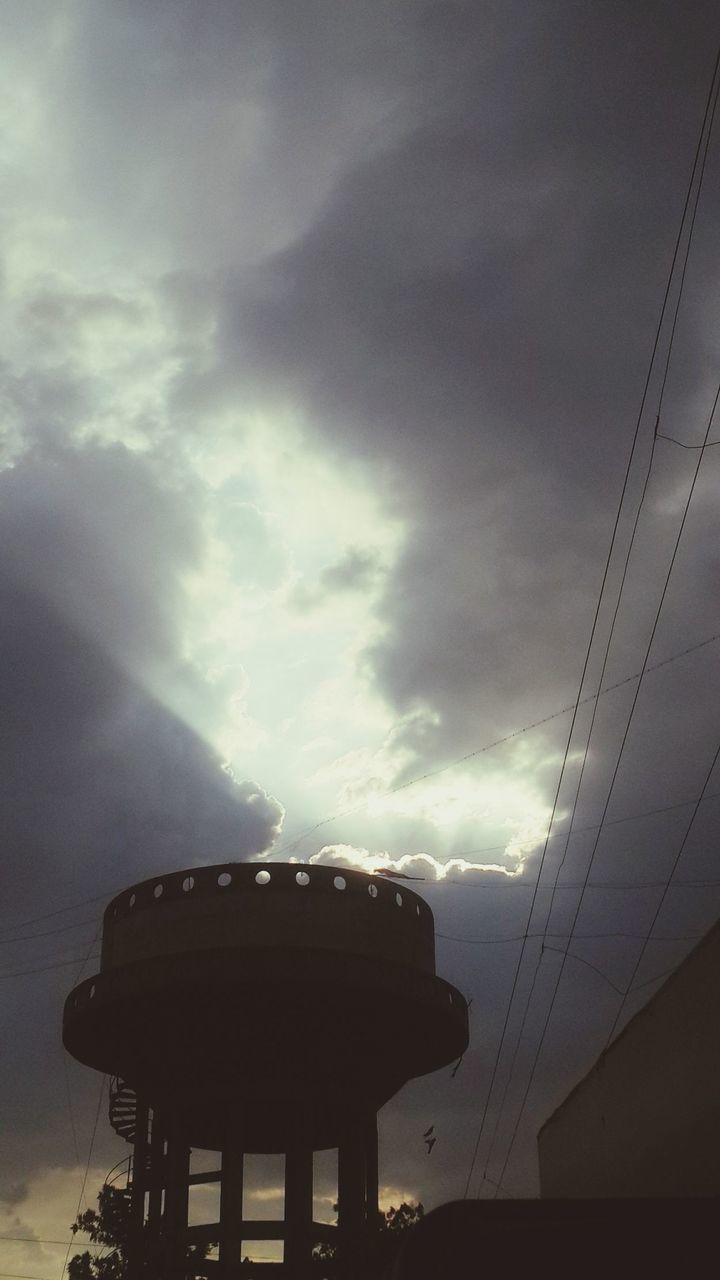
<box><xmin>63</xmin><ymin>863</ymin><xmax>468</xmax><ymax>1280</ymax></box>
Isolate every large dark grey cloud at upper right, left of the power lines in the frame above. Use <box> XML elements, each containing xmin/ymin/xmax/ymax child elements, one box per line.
<box><xmin>228</xmin><ymin>4</ymin><xmax>716</xmax><ymax>768</ymax></box>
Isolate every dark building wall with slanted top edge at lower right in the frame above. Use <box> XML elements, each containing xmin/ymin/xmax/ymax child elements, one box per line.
<box><xmin>538</xmin><ymin>922</ymin><xmax>720</xmax><ymax>1197</ymax></box>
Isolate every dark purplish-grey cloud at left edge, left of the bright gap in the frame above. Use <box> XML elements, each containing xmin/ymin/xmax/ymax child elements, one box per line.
<box><xmin>0</xmin><ymin>448</ymin><xmax>282</xmax><ymax>1181</ymax></box>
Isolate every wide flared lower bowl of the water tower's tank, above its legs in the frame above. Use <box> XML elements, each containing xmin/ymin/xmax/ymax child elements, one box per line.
<box><xmin>63</xmin><ymin>946</ymin><xmax>468</xmax><ymax>1152</ymax></box>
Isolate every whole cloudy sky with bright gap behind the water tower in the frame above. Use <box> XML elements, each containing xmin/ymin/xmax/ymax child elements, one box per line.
<box><xmin>0</xmin><ymin>0</ymin><xmax>720</xmax><ymax>1280</ymax></box>
